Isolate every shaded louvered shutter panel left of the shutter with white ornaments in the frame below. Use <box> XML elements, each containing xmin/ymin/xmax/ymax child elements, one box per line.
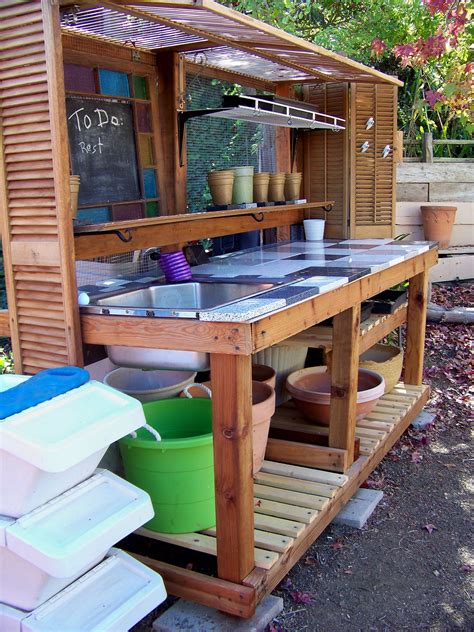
<box><xmin>303</xmin><ymin>83</ymin><xmax>349</xmax><ymax>237</ymax></box>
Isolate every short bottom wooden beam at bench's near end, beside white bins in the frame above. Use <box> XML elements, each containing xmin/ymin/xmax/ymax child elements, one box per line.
<box><xmin>129</xmin><ymin>552</ymin><xmax>256</xmax><ymax>619</ymax></box>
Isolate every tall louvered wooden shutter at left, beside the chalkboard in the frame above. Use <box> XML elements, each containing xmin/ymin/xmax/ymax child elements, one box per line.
<box><xmin>0</xmin><ymin>0</ymin><xmax>82</xmax><ymax>373</ymax></box>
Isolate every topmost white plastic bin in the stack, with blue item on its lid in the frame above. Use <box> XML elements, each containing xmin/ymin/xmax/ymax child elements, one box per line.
<box><xmin>0</xmin><ymin>375</ymin><xmax>145</xmax><ymax>518</ymax></box>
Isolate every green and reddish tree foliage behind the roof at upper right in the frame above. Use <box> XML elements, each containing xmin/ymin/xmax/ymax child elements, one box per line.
<box><xmin>222</xmin><ymin>0</ymin><xmax>473</xmax><ymax>150</ymax></box>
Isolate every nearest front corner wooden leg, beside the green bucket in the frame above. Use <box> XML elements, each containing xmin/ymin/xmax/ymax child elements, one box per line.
<box><xmin>211</xmin><ymin>354</ymin><xmax>255</xmax><ymax>583</ymax></box>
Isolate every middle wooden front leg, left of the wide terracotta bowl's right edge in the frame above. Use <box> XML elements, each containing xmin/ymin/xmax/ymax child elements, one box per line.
<box><xmin>329</xmin><ymin>304</ymin><xmax>360</xmax><ymax>465</ymax></box>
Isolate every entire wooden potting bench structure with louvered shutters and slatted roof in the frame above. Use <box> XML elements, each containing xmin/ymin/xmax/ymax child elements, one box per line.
<box><xmin>0</xmin><ymin>0</ymin><xmax>437</xmax><ymax>617</ymax></box>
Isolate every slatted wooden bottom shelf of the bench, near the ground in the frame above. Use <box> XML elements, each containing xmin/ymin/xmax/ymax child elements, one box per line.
<box><xmin>136</xmin><ymin>383</ymin><xmax>429</xmax><ymax>608</ymax></box>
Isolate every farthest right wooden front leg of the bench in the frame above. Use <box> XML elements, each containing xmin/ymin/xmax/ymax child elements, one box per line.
<box><xmin>405</xmin><ymin>270</ymin><xmax>429</xmax><ymax>385</ymax></box>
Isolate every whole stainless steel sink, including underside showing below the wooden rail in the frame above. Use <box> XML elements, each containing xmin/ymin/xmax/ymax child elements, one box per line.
<box><xmin>81</xmin><ymin>281</ymin><xmax>275</xmax><ymax>371</ymax></box>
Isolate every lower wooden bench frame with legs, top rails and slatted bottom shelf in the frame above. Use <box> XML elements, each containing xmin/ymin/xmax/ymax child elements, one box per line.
<box><xmin>76</xmin><ymin>225</ymin><xmax>437</xmax><ymax>617</ymax></box>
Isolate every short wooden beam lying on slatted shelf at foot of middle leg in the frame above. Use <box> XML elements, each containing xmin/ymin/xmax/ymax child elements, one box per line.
<box><xmin>265</xmin><ymin>438</ymin><xmax>346</xmax><ymax>472</ymax></box>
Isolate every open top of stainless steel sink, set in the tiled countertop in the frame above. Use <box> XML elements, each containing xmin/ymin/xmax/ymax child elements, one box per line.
<box><xmin>88</xmin><ymin>282</ymin><xmax>274</xmax><ymax>318</ymax></box>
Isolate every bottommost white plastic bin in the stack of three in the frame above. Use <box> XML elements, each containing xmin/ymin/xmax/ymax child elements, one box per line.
<box><xmin>0</xmin><ymin>549</ymin><xmax>166</xmax><ymax>632</ymax></box>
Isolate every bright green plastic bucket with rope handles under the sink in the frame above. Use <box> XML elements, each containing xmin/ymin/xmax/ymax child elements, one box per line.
<box><xmin>120</xmin><ymin>398</ymin><xmax>216</xmax><ymax>533</ymax></box>
